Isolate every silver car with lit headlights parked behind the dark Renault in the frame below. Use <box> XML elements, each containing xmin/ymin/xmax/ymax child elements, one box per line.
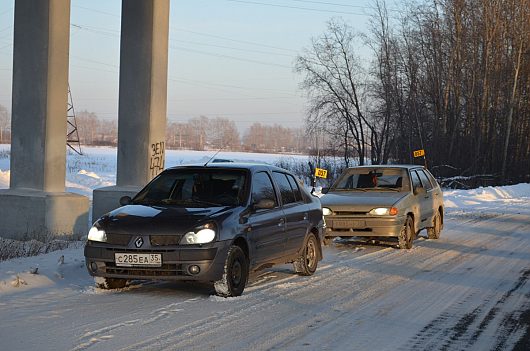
<box><xmin>320</xmin><ymin>165</ymin><xmax>444</xmax><ymax>249</ymax></box>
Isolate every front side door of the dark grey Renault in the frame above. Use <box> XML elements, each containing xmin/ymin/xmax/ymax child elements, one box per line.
<box><xmin>247</xmin><ymin>171</ymin><xmax>285</xmax><ymax>265</ymax></box>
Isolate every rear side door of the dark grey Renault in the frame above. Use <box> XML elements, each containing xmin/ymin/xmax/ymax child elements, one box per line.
<box><xmin>272</xmin><ymin>172</ymin><xmax>309</xmax><ymax>255</ymax></box>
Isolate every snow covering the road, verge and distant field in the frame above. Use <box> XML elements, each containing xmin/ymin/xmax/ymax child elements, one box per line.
<box><xmin>0</xmin><ymin>144</ymin><xmax>530</xmax><ymax>350</ymax></box>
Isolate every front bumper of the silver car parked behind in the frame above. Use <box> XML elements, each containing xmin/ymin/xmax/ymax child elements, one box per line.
<box><xmin>324</xmin><ymin>215</ymin><xmax>406</xmax><ymax>238</ymax></box>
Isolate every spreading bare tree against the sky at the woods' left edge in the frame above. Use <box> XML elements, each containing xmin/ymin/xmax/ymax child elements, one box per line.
<box><xmin>296</xmin><ymin>19</ymin><xmax>378</xmax><ymax>165</ymax></box>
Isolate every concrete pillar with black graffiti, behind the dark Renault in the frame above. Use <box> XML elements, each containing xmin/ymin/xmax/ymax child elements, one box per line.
<box><xmin>92</xmin><ymin>0</ymin><xmax>169</xmax><ymax>220</ymax></box>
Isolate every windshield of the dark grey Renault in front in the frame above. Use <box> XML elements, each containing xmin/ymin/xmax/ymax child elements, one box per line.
<box><xmin>133</xmin><ymin>169</ymin><xmax>247</xmax><ymax>207</ymax></box>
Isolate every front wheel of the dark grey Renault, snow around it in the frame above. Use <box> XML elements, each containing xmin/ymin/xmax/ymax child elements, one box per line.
<box><xmin>214</xmin><ymin>245</ymin><xmax>249</xmax><ymax>297</ymax></box>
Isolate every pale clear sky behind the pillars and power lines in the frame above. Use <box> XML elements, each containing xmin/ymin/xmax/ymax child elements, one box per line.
<box><xmin>0</xmin><ymin>0</ymin><xmax>382</xmax><ymax>130</ymax></box>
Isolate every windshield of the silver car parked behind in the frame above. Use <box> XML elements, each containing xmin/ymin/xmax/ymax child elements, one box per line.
<box><xmin>330</xmin><ymin>168</ymin><xmax>410</xmax><ymax>191</ymax></box>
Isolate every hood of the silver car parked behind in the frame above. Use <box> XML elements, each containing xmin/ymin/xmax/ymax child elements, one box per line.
<box><xmin>320</xmin><ymin>191</ymin><xmax>407</xmax><ymax>212</ymax></box>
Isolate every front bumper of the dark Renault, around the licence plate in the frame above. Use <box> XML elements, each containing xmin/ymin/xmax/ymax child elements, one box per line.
<box><xmin>85</xmin><ymin>240</ymin><xmax>231</xmax><ymax>282</ymax></box>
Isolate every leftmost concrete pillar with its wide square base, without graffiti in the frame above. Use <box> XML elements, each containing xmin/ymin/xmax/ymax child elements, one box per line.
<box><xmin>0</xmin><ymin>0</ymin><xmax>89</xmax><ymax>240</ymax></box>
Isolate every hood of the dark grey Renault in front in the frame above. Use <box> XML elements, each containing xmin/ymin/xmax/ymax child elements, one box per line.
<box><xmin>98</xmin><ymin>205</ymin><xmax>234</xmax><ymax>235</ymax></box>
